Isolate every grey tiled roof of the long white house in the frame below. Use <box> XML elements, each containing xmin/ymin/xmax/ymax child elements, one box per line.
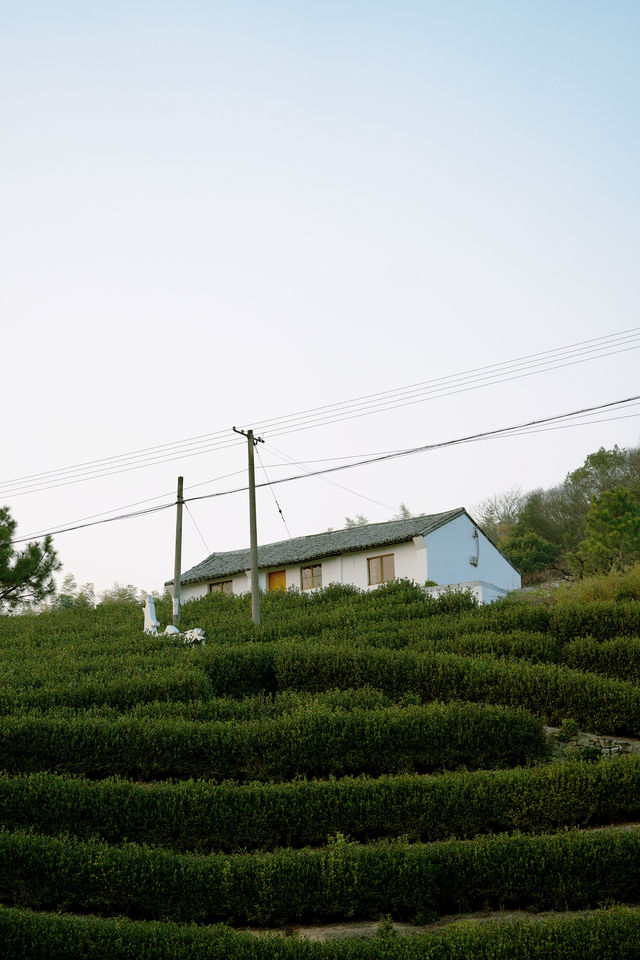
<box><xmin>171</xmin><ymin>507</ymin><xmax>466</xmax><ymax>586</ymax></box>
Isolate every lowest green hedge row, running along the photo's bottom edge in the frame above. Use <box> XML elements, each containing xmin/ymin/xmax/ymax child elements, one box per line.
<box><xmin>0</xmin><ymin>907</ymin><xmax>640</xmax><ymax>960</ymax></box>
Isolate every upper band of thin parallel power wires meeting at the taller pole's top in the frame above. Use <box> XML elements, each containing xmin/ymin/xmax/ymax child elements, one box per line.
<box><xmin>0</xmin><ymin>327</ymin><xmax>640</xmax><ymax>497</ymax></box>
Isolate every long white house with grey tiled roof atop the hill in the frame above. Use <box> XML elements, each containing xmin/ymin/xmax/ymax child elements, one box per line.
<box><xmin>166</xmin><ymin>507</ymin><xmax>520</xmax><ymax>603</ymax></box>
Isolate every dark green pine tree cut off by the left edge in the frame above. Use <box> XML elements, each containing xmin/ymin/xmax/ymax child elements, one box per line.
<box><xmin>0</xmin><ymin>507</ymin><xmax>62</xmax><ymax>612</ymax></box>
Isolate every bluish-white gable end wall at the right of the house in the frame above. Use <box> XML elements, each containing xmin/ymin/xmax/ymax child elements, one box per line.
<box><xmin>423</xmin><ymin>514</ymin><xmax>521</xmax><ymax>590</ymax></box>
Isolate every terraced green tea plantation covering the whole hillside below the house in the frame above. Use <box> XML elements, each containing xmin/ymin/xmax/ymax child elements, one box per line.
<box><xmin>0</xmin><ymin>581</ymin><xmax>640</xmax><ymax>960</ymax></box>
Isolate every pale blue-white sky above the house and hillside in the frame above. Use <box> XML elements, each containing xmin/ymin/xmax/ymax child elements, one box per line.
<box><xmin>0</xmin><ymin>0</ymin><xmax>640</xmax><ymax>591</ymax></box>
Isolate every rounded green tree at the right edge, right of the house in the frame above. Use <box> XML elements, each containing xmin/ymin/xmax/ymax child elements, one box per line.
<box><xmin>572</xmin><ymin>487</ymin><xmax>640</xmax><ymax>573</ymax></box>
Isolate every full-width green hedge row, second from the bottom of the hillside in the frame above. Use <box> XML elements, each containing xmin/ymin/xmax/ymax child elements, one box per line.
<box><xmin>0</xmin><ymin>828</ymin><xmax>640</xmax><ymax>926</ymax></box>
